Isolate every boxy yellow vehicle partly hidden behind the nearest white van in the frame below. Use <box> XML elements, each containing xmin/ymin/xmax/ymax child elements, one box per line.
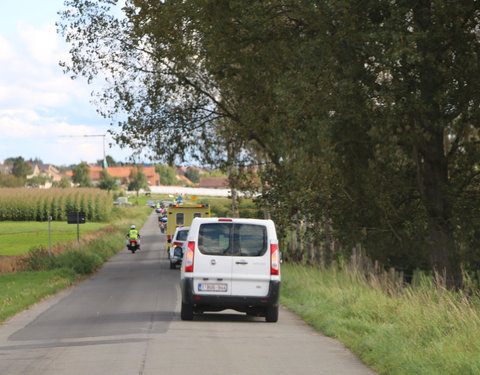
<box><xmin>167</xmin><ymin>203</ymin><xmax>210</xmax><ymax>253</ymax></box>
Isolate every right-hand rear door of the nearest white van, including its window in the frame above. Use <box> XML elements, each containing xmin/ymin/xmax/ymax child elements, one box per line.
<box><xmin>231</xmin><ymin>225</ymin><xmax>270</xmax><ymax>297</ymax></box>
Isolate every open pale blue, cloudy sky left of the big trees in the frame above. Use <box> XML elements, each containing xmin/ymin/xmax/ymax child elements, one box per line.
<box><xmin>0</xmin><ymin>0</ymin><xmax>138</xmax><ymax>166</ymax></box>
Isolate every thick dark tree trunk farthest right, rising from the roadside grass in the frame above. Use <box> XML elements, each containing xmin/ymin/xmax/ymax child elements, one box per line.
<box><xmin>412</xmin><ymin>1</ymin><xmax>462</xmax><ymax>288</ymax></box>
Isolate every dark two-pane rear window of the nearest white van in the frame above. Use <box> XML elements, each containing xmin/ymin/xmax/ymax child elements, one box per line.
<box><xmin>198</xmin><ymin>223</ymin><xmax>267</xmax><ymax>257</ymax></box>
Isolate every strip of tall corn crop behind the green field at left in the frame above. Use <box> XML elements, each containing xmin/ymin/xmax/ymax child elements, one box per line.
<box><xmin>0</xmin><ymin>188</ymin><xmax>113</xmax><ymax>222</ymax></box>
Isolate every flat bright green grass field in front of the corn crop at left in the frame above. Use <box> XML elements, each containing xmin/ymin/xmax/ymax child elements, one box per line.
<box><xmin>0</xmin><ymin>221</ymin><xmax>108</xmax><ymax>256</ymax></box>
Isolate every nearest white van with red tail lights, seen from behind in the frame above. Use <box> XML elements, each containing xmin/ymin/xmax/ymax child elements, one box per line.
<box><xmin>180</xmin><ymin>218</ymin><xmax>280</xmax><ymax>322</ymax></box>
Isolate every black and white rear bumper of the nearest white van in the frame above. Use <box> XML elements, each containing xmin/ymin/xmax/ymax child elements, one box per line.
<box><xmin>181</xmin><ymin>278</ymin><xmax>280</xmax><ymax>312</ymax></box>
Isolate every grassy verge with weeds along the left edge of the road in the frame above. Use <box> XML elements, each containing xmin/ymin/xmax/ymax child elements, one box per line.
<box><xmin>0</xmin><ymin>207</ymin><xmax>151</xmax><ymax>323</ymax></box>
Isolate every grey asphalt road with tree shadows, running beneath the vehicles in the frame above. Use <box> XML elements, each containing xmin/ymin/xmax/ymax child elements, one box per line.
<box><xmin>0</xmin><ymin>214</ymin><xmax>375</xmax><ymax>375</ymax></box>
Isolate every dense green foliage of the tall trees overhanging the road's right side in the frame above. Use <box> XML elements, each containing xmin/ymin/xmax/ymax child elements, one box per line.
<box><xmin>61</xmin><ymin>0</ymin><xmax>480</xmax><ymax>286</ymax></box>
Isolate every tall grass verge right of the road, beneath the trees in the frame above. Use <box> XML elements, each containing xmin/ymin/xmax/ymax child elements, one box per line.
<box><xmin>281</xmin><ymin>263</ymin><xmax>480</xmax><ymax>375</ymax></box>
